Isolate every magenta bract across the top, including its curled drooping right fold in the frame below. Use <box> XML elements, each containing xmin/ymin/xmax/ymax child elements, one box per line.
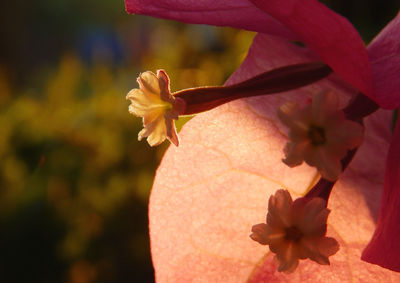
<box><xmin>125</xmin><ymin>0</ymin><xmax>372</xmax><ymax>101</ymax></box>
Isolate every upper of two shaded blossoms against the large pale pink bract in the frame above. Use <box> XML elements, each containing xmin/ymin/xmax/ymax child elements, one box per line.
<box><xmin>278</xmin><ymin>92</ymin><xmax>363</xmax><ymax>181</ymax></box>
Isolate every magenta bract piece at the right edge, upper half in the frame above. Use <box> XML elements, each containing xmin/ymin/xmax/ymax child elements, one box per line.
<box><xmin>368</xmin><ymin>13</ymin><xmax>400</xmax><ymax>109</ymax></box>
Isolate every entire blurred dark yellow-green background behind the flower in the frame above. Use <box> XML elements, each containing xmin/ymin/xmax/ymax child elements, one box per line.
<box><xmin>0</xmin><ymin>0</ymin><xmax>400</xmax><ymax>283</ymax></box>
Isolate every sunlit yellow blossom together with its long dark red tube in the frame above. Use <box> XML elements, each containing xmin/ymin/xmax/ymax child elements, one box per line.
<box><xmin>126</xmin><ymin>62</ymin><xmax>332</xmax><ymax>146</ymax></box>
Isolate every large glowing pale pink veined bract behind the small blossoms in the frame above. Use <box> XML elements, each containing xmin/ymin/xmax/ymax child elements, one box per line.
<box><xmin>149</xmin><ymin>36</ymin><xmax>400</xmax><ymax>282</ymax></box>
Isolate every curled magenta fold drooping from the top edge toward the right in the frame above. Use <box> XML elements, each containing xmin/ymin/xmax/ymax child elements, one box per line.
<box><xmin>251</xmin><ymin>0</ymin><xmax>372</xmax><ymax>98</ymax></box>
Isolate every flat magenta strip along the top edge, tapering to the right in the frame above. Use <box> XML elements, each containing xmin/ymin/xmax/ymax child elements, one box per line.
<box><xmin>125</xmin><ymin>0</ymin><xmax>296</xmax><ymax>39</ymax></box>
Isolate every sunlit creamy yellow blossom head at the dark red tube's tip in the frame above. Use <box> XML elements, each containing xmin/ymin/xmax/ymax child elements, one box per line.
<box><xmin>126</xmin><ymin>70</ymin><xmax>186</xmax><ymax>146</ymax></box>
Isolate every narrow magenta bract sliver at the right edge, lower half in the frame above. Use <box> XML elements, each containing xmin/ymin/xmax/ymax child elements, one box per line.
<box><xmin>362</xmin><ymin>122</ymin><xmax>400</xmax><ymax>271</ymax></box>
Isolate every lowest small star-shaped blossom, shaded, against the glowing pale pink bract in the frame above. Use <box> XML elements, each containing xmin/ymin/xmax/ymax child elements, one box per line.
<box><xmin>250</xmin><ymin>190</ymin><xmax>339</xmax><ymax>273</ymax></box>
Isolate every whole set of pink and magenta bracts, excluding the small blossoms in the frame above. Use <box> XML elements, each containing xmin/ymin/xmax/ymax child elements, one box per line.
<box><xmin>126</xmin><ymin>0</ymin><xmax>400</xmax><ymax>282</ymax></box>
